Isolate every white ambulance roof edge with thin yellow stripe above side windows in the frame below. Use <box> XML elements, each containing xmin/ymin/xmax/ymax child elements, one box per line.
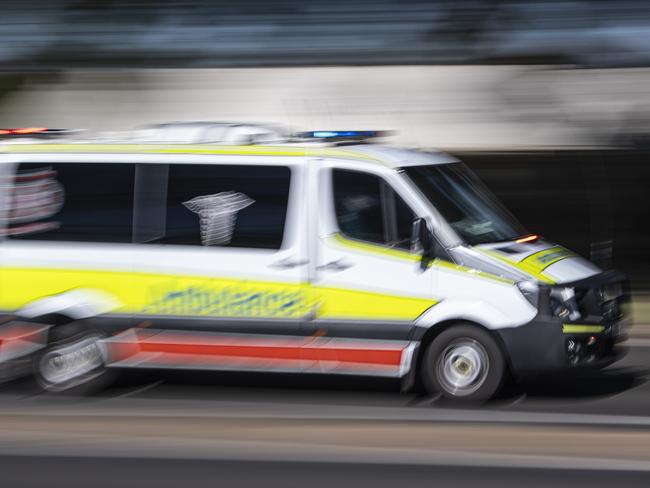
<box><xmin>0</xmin><ymin>143</ymin><xmax>457</xmax><ymax>168</ymax></box>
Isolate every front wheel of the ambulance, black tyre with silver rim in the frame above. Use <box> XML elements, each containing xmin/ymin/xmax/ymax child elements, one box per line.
<box><xmin>421</xmin><ymin>324</ymin><xmax>506</xmax><ymax>402</ymax></box>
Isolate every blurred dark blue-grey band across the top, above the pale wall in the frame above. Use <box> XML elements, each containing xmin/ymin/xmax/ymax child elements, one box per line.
<box><xmin>0</xmin><ymin>0</ymin><xmax>650</xmax><ymax>68</ymax></box>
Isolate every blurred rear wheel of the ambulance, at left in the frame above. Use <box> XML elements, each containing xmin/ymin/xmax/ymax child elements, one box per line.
<box><xmin>33</xmin><ymin>322</ymin><xmax>113</xmax><ymax>395</ymax></box>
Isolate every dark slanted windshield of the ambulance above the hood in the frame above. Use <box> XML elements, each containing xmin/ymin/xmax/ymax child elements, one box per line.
<box><xmin>402</xmin><ymin>163</ymin><xmax>527</xmax><ymax>245</ymax></box>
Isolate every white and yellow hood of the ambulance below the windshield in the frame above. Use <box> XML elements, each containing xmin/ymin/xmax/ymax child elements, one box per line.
<box><xmin>473</xmin><ymin>239</ymin><xmax>601</xmax><ymax>284</ymax></box>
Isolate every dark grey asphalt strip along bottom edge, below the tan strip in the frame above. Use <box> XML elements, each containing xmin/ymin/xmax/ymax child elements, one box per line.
<box><xmin>0</xmin><ymin>457</ymin><xmax>650</xmax><ymax>488</ymax></box>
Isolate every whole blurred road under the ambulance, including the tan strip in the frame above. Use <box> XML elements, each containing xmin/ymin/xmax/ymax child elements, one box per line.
<box><xmin>0</xmin><ymin>341</ymin><xmax>650</xmax><ymax>487</ymax></box>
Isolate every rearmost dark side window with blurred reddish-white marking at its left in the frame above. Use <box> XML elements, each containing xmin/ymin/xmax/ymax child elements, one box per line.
<box><xmin>7</xmin><ymin>163</ymin><xmax>135</xmax><ymax>243</ymax></box>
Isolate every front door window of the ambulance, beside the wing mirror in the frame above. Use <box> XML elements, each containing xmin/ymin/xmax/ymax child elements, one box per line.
<box><xmin>332</xmin><ymin>169</ymin><xmax>415</xmax><ymax>250</ymax></box>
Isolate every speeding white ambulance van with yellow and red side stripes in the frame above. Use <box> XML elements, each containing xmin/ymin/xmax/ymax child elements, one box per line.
<box><xmin>0</xmin><ymin>124</ymin><xmax>627</xmax><ymax>401</ymax></box>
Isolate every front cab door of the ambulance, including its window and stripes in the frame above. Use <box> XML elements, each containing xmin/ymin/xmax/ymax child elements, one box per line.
<box><xmin>312</xmin><ymin>166</ymin><xmax>435</xmax><ymax>376</ymax></box>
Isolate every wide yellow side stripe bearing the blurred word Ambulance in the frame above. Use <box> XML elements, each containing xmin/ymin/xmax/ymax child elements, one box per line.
<box><xmin>0</xmin><ymin>268</ymin><xmax>436</xmax><ymax>320</ymax></box>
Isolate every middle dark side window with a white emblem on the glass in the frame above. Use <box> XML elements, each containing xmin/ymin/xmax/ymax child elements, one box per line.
<box><xmin>135</xmin><ymin>164</ymin><xmax>291</xmax><ymax>249</ymax></box>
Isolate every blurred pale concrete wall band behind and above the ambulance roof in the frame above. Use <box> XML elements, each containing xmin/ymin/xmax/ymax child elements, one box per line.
<box><xmin>0</xmin><ymin>66</ymin><xmax>650</xmax><ymax>149</ymax></box>
